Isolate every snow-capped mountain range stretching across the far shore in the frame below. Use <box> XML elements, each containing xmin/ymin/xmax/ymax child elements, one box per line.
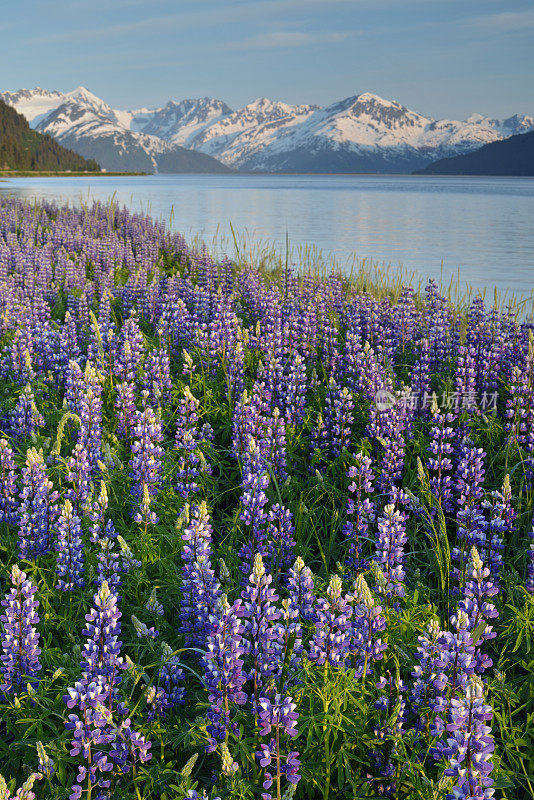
<box><xmin>0</xmin><ymin>87</ymin><xmax>534</xmax><ymax>172</ymax></box>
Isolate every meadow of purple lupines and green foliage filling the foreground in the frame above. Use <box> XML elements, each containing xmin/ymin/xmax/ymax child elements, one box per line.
<box><xmin>0</xmin><ymin>198</ymin><xmax>534</xmax><ymax>800</ymax></box>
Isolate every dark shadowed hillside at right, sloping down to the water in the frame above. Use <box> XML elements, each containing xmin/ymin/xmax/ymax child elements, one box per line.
<box><xmin>417</xmin><ymin>131</ymin><xmax>534</xmax><ymax>176</ymax></box>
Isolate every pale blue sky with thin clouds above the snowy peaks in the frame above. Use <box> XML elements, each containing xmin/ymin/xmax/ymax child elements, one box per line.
<box><xmin>0</xmin><ymin>0</ymin><xmax>534</xmax><ymax>118</ymax></box>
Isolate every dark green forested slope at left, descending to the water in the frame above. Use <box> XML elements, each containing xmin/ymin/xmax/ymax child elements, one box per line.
<box><xmin>0</xmin><ymin>99</ymin><xmax>100</xmax><ymax>172</ymax></box>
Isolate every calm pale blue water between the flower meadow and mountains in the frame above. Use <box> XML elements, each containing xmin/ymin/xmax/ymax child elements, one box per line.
<box><xmin>0</xmin><ymin>175</ymin><xmax>534</xmax><ymax>304</ymax></box>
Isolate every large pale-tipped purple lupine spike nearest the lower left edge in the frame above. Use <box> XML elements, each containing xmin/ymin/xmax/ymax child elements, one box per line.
<box><xmin>0</xmin><ymin>564</ymin><xmax>41</xmax><ymax>697</ymax></box>
